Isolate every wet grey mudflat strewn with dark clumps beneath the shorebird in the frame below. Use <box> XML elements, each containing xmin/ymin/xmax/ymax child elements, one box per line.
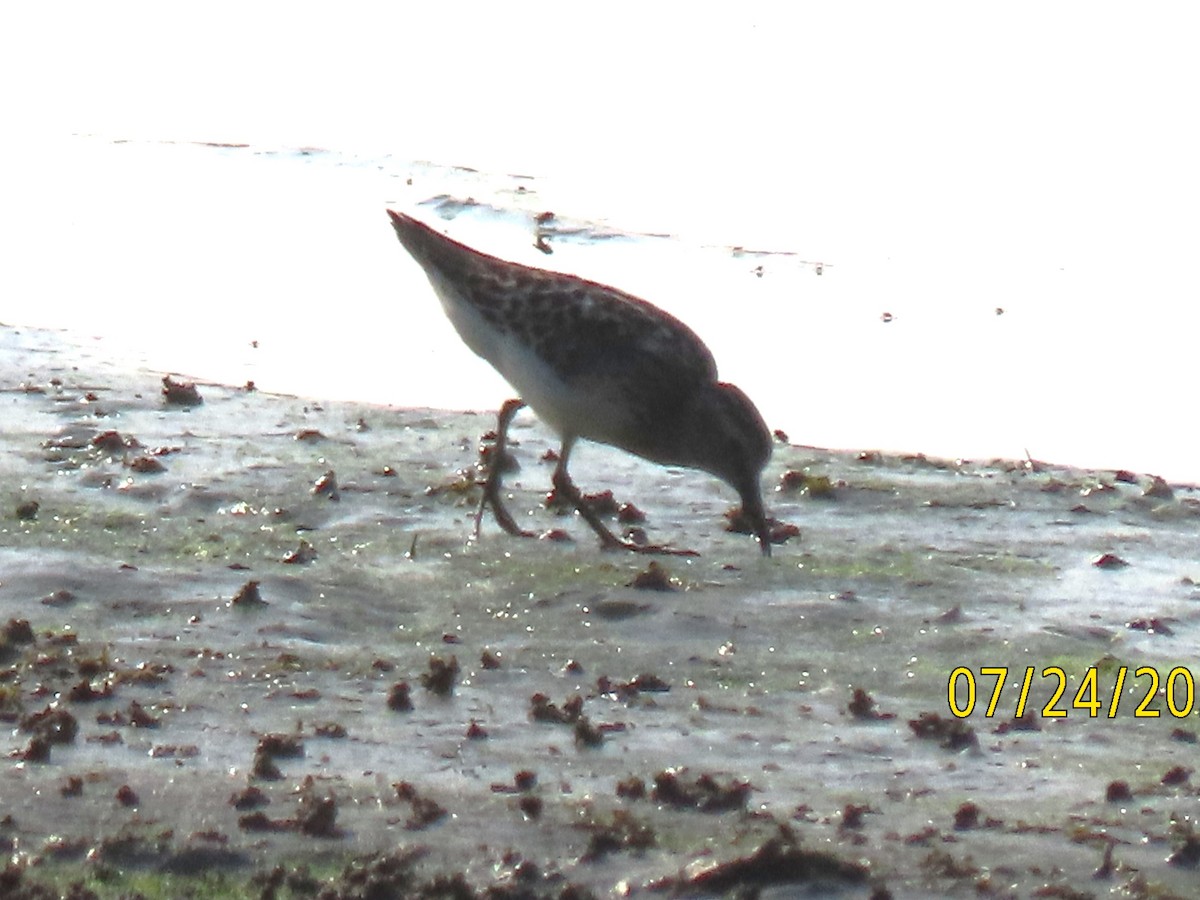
<box><xmin>0</xmin><ymin>329</ymin><xmax>1200</xmax><ymax>896</ymax></box>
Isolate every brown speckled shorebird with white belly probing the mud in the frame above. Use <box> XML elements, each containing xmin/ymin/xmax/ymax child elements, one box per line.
<box><xmin>388</xmin><ymin>210</ymin><xmax>772</xmax><ymax>556</ymax></box>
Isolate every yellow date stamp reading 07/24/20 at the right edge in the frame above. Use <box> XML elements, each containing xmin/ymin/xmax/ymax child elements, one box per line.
<box><xmin>947</xmin><ymin>666</ymin><xmax>1196</xmax><ymax>719</ymax></box>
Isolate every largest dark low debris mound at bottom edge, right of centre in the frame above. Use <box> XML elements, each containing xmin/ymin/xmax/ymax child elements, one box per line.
<box><xmin>647</xmin><ymin>826</ymin><xmax>870</xmax><ymax>896</ymax></box>
